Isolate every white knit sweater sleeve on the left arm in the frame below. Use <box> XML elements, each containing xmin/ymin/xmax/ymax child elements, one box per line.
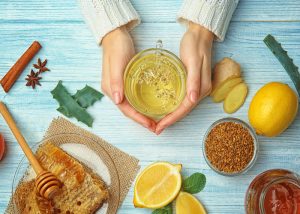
<box><xmin>79</xmin><ymin>0</ymin><xmax>140</xmax><ymax>45</ymax></box>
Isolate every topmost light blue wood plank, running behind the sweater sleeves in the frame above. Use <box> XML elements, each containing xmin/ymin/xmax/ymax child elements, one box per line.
<box><xmin>0</xmin><ymin>0</ymin><xmax>300</xmax><ymax>23</ymax></box>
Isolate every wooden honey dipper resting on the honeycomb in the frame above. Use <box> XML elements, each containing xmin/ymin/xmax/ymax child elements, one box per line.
<box><xmin>0</xmin><ymin>102</ymin><xmax>61</xmax><ymax>199</ymax></box>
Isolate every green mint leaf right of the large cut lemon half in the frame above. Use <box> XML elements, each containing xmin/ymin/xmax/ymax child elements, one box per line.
<box><xmin>183</xmin><ymin>172</ymin><xmax>206</xmax><ymax>194</ymax></box>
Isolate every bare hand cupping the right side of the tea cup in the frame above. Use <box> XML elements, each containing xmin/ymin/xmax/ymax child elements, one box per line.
<box><xmin>155</xmin><ymin>22</ymin><xmax>214</xmax><ymax>134</ymax></box>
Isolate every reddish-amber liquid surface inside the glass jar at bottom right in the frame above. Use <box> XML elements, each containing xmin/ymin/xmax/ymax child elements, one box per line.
<box><xmin>264</xmin><ymin>182</ymin><xmax>300</xmax><ymax>214</ymax></box>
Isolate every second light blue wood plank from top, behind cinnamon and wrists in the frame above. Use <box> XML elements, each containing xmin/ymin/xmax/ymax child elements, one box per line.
<box><xmin>0</xmin><ymin>22</ymin><xmax>300</xmax><ymax>86</ymax></box>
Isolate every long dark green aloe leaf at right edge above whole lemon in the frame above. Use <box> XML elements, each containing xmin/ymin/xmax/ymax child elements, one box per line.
<box><xmin>264</xmin><ymin>34</ymin><xmax>300</xmax><ymax>96</ymax></box>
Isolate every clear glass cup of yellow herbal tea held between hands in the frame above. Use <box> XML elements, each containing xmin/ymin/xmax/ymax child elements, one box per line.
<box><xmin>124</xmin><ymin>40</ymin><xmax>186</xmax><ymax>120</ymax></box>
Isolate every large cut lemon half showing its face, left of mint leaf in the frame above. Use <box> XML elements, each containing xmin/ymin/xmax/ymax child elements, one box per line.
<box><xmin>133</xmin><ymin>162</ymin><xmax>182</xmax><ymax>209</ymax></box>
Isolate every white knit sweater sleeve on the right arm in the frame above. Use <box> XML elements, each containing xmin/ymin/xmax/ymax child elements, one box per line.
<box><xmin>177</xmin><ymin>0</ymin><xmax>239</xmax><ymax>41</ymax></box>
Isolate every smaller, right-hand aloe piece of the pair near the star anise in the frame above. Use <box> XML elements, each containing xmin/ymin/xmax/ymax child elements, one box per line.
<box><xmin>73</xmin><ymin>85</ymin><xmax>103</xmax><ymax>108</ymax></box>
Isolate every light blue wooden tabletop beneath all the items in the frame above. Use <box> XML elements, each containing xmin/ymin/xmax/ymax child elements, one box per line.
<box><xmin>0</xmin><ymin>0</ymin><xmax>300</xmax><ymax>214</ymax></box>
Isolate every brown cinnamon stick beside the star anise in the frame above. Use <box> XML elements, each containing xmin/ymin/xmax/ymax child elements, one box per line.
<box><xmin>0</xmin><ymin>41</ymin><xmax>42</xmax><ymax>93</ymax></box>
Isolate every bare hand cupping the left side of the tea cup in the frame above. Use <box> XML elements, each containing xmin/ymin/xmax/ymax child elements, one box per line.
<box><xmin>101</xmin><ymin>27</ymin><xmax>156</xmax><ymax>132</ymax></box>
